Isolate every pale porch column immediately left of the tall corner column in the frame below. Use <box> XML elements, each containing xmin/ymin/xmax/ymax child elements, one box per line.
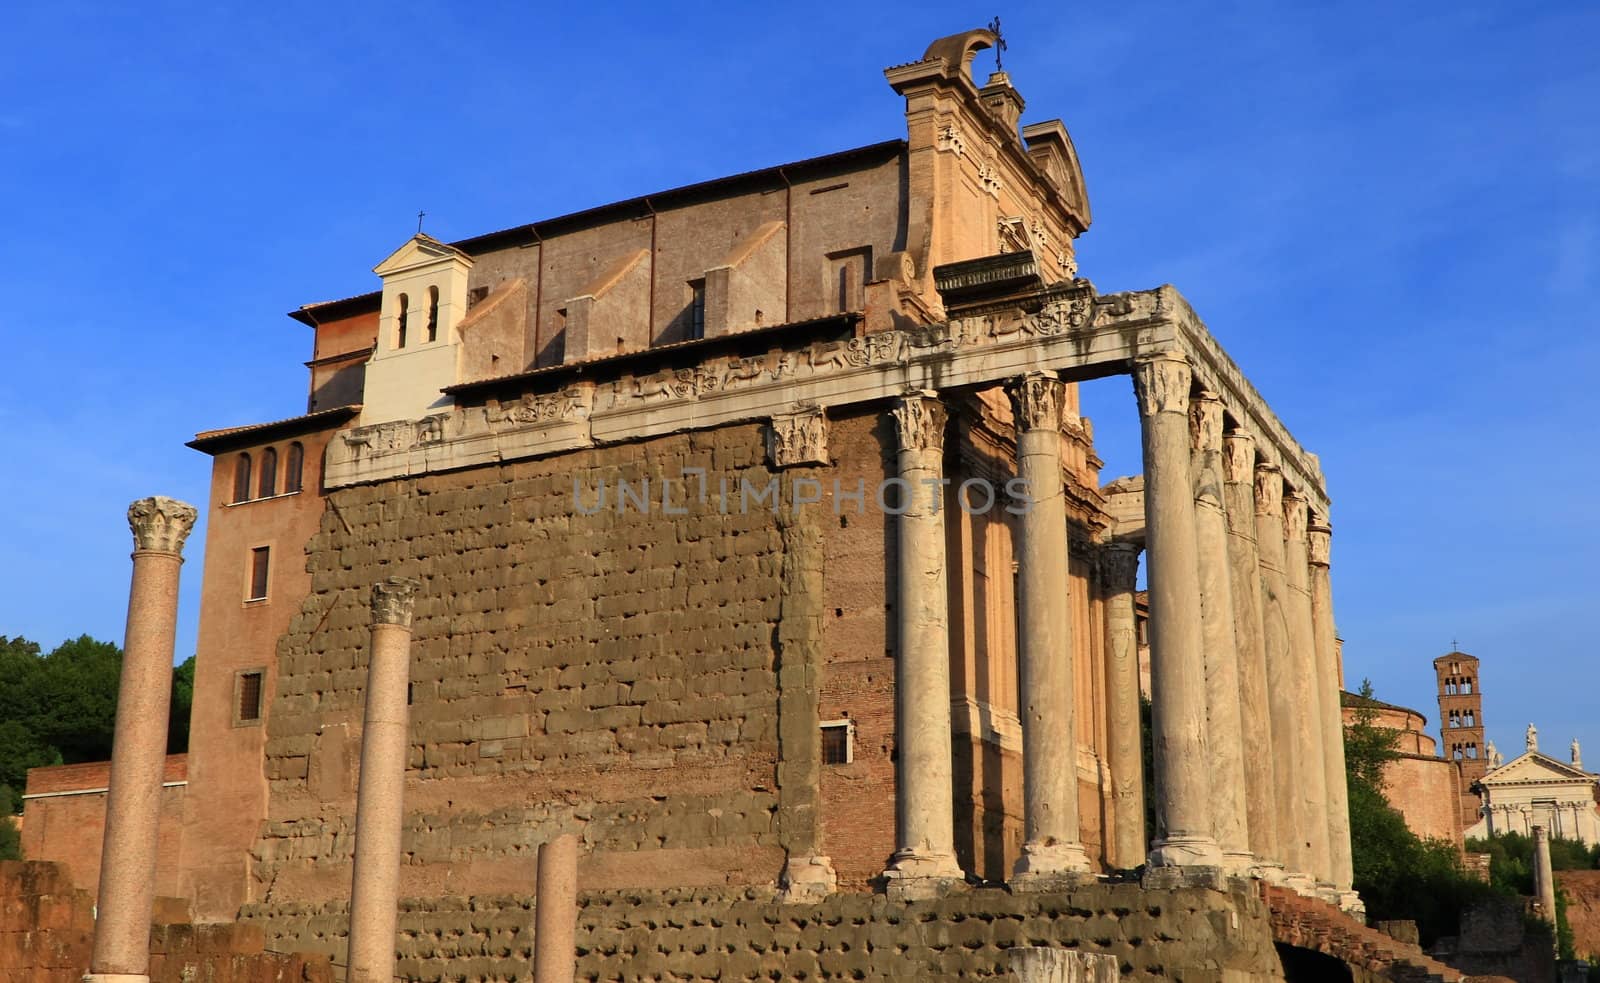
<box><xmin>1008</xmin><ymin>373</ymin><xmax>1090</xmax><ymax>882</ymax></box>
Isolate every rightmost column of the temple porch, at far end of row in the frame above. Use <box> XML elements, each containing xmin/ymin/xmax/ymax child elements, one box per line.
<box><xmin>1306</xmin><ymin>525</ymin><xmax>1365</xmax><ymax>911</ymax></box>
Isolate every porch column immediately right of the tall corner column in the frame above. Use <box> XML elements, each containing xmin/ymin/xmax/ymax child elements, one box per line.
<box><xmin>1189</xmin><ymin>392</ymin><xmax>1254</xmax><ymax>876</ymax></box>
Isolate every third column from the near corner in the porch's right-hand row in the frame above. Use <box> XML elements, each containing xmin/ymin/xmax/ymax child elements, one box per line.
<box><xmin>1222</xmin><ymin>429</ymin><xmax>1283</xmax><ymax>882</ymax></box>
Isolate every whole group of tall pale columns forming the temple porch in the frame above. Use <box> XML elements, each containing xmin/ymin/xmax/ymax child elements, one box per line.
<box><xmin>885</xmin><ymin>352</ymin><xmax>1360</xmax><ymax>908</ymax></box>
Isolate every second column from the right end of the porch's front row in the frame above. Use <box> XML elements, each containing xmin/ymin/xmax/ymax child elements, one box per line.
<box><xmin>1283</xmin><ymin>492</ymin><xmax>1336</xmax><ymax>901</ymax></box>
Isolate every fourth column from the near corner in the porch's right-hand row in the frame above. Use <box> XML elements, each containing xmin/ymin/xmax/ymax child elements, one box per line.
<box><xmin>1256</xmin><ymin>463</ymin><xmax>1326</xmax><ymax>893</ymax></box>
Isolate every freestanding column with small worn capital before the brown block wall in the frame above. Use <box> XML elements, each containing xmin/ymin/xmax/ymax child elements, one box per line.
<box><xmin>349</xmin><ymin>576</ymin><xmax>419</xmax><ymax>983</ymax></box>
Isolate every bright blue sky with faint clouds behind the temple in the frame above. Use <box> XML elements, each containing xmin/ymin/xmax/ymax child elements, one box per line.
<box><xmin>0</xmin><ymin>0</ymin><xmax>1600</xmax><ymax>767</ymax></box>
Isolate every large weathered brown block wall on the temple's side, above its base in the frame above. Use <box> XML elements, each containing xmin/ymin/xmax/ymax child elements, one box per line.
<box><xmin>254</xmin><ymin>424</ymin><xmax>782</xmax><ymax>901</ymax></box>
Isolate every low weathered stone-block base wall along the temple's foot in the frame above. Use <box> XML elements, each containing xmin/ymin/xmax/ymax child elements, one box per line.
<box><xmin>245</xmin><ymin>884</ymin><xmax>1283</xmax><ymax>983</ymax></box>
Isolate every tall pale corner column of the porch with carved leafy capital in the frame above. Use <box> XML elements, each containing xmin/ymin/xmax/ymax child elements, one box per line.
<box><xmin>1133</xmin><ymin>352</ymin><xmax>1222</xmax><ymax>868</ymax></box>
